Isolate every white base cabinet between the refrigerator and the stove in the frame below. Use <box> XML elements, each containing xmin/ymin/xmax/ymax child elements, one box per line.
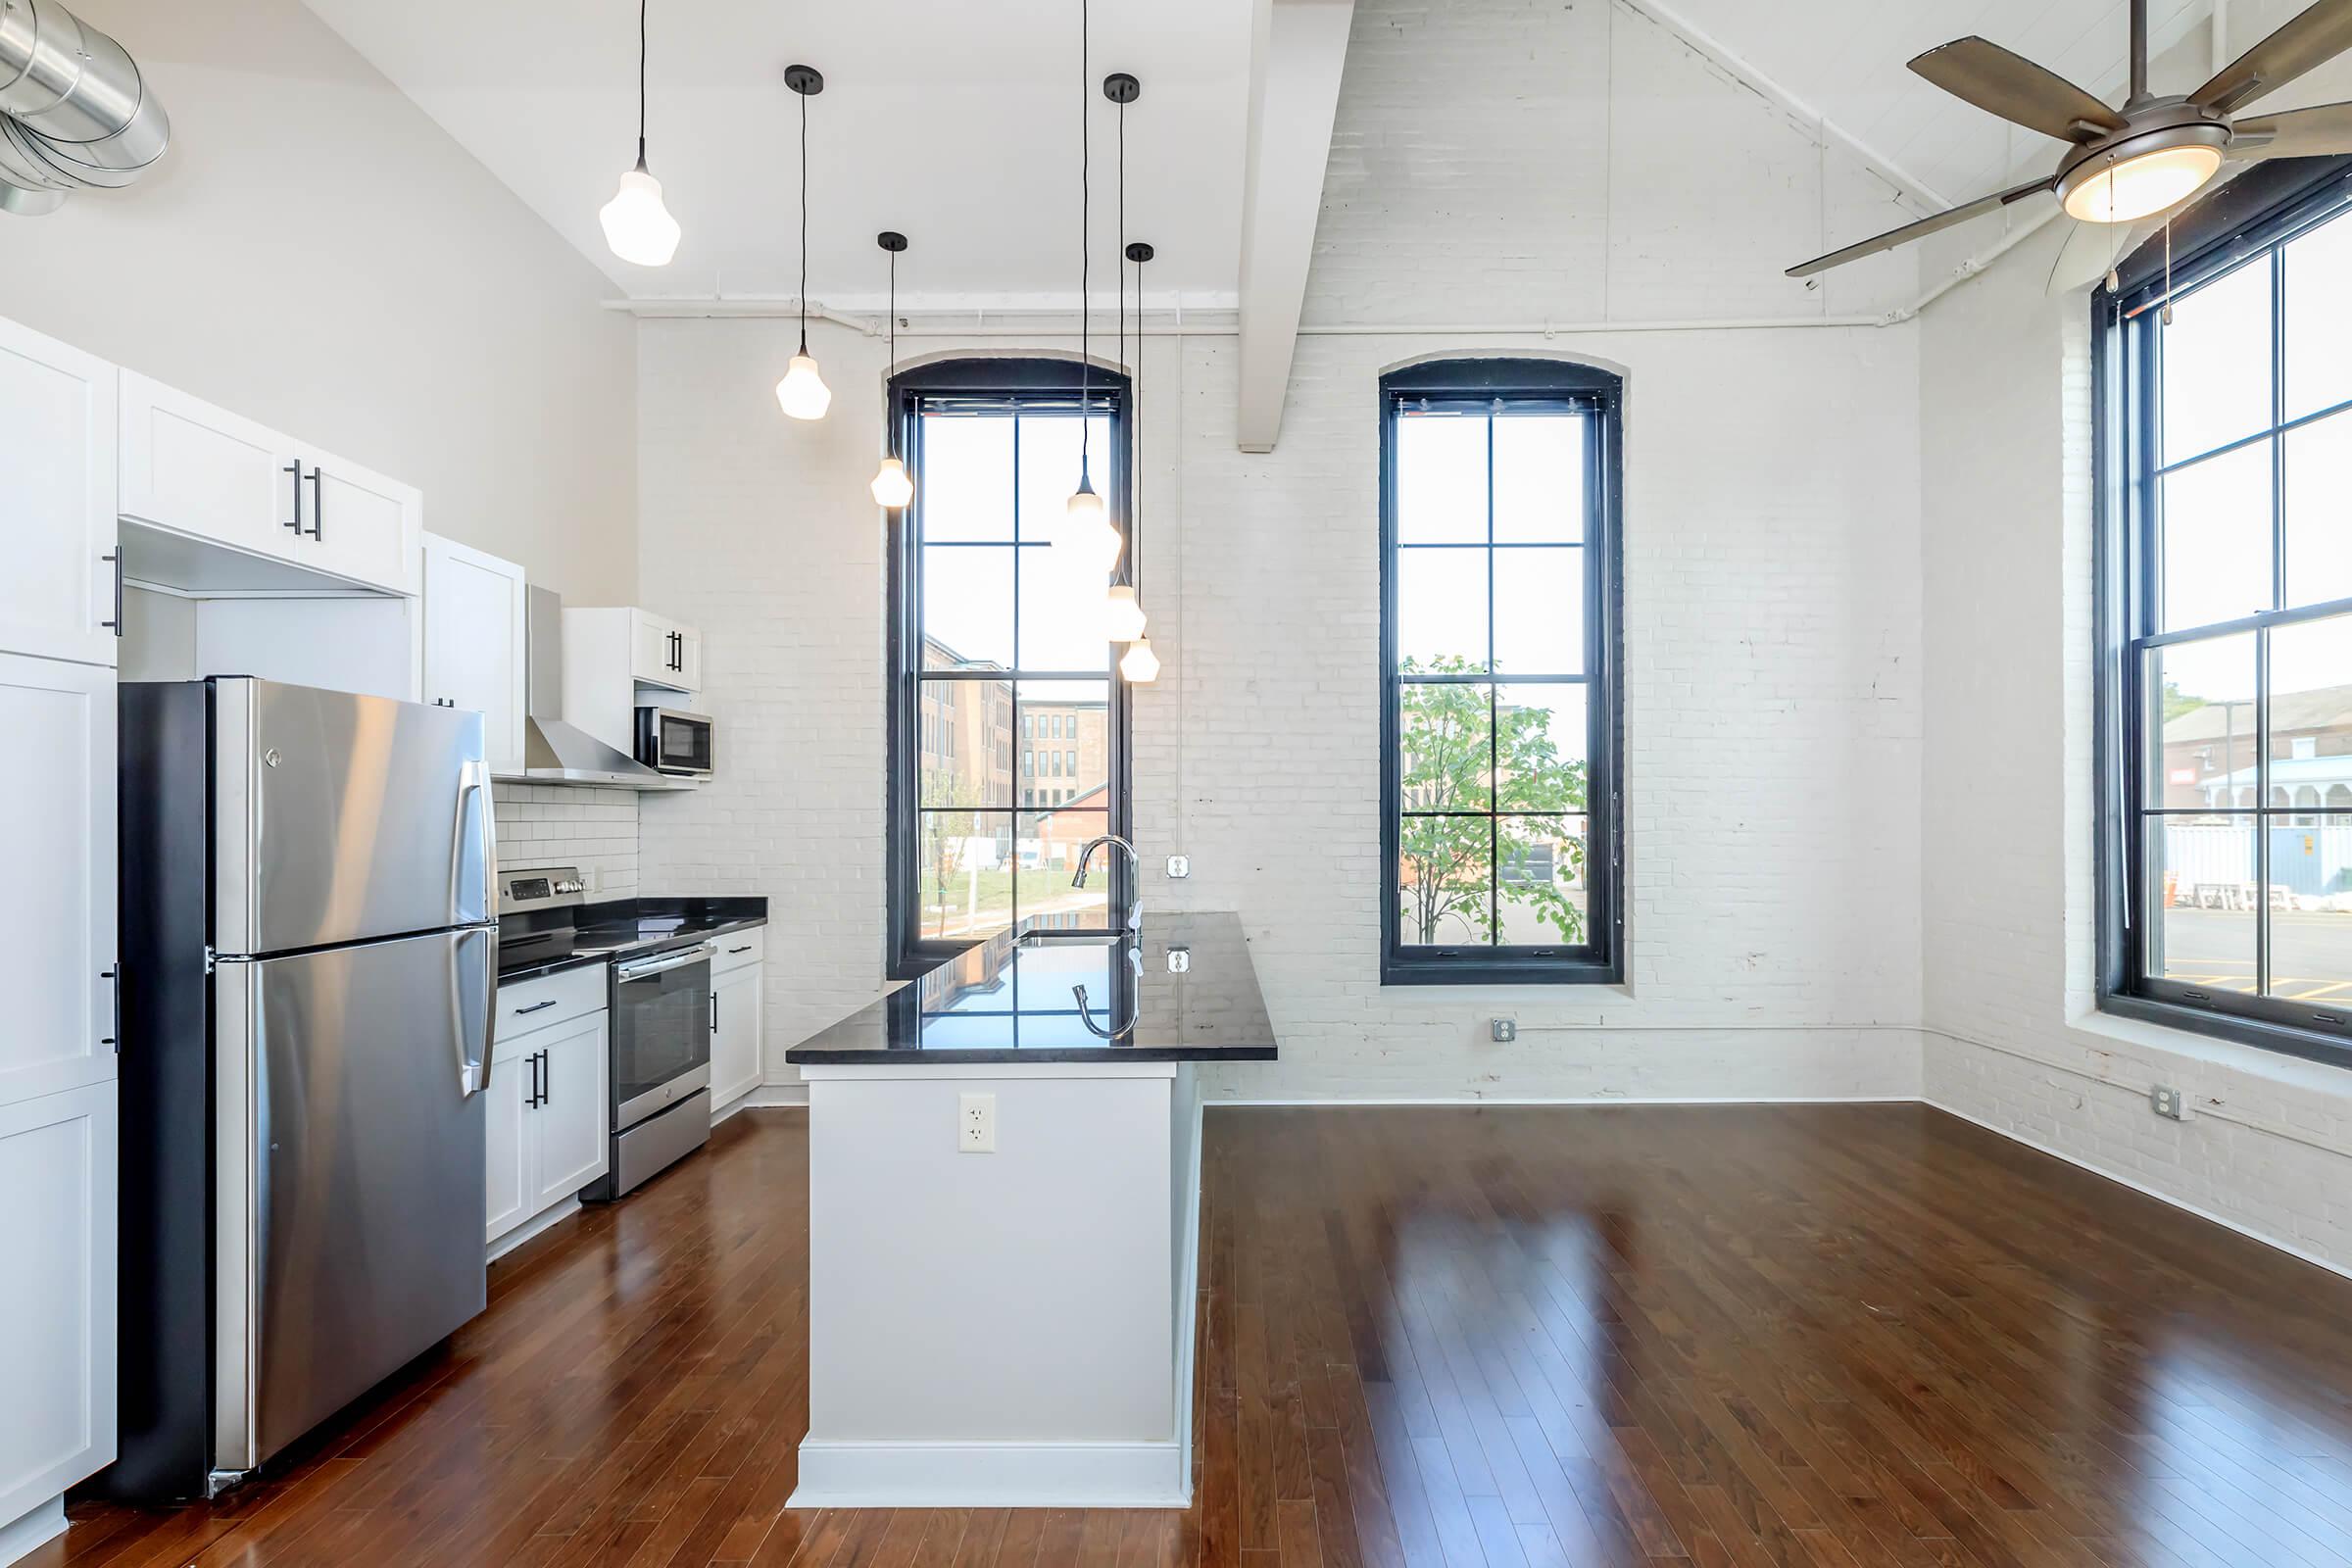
<box><xmin>482</xmin><ymin>982</ymin><xmax>612</xmax><ymax>1242</ymax></box>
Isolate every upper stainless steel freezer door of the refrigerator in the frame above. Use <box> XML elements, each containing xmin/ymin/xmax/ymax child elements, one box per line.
<box><xmin>214</xmin><ymin>677</ymin><xmax>499</xmax><ymax>955</ymax></box>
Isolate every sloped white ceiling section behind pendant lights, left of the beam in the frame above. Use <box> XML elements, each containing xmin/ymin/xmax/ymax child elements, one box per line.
<box><xmin>308</xmin><ymin>0</ymin><xmax>1251</xmax><ymax>311</ymax></box>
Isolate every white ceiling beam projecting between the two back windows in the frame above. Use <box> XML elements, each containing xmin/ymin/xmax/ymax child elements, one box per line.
<box><xmin>1240</xmin><ymin>0</ymin><xmax>1354</xmax><ymax>452</ymax></box>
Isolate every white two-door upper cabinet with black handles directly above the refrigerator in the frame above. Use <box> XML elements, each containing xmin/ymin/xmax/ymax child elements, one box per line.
<box><xmin>120</xmin><ymin>371</ymin><xmax>423</xmax><ymax>595</ymax></box>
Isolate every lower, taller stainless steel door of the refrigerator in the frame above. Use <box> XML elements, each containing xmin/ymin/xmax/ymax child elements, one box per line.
<box><xmin>214</xmin><ymin>931</ymin><xmax>499</xmax><ymax>1472</ymax></box>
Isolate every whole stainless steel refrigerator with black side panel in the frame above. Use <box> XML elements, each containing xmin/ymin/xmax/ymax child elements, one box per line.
<box><xmin>104</xmin><ymin>677</ymin><xmax>499</xmax><ymax>1499</ymax></box>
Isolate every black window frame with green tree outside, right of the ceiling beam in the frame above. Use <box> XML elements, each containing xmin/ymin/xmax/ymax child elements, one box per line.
<box><xmin>1378</xmin><ymin>358</ymin><xmax>1625</xmax><ymax>985</ymax></box>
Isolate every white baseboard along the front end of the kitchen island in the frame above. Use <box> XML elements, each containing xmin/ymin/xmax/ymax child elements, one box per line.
<box><xmin>786</xmin><ymin>1439</ymin><xmax>1193</xmax><ymax>1509</ymax></box>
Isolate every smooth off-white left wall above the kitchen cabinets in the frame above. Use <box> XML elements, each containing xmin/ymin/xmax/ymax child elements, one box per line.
<box><xmin>0</xmin><ymin>0</ymin><xmax>635</xmax><ymax>604</ymax></box>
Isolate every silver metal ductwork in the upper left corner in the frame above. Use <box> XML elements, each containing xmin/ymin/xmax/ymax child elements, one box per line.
<box><xmin>0</xmin><ymin>0</ymin><xmax>172</xmax><ymax>214</ymax></box>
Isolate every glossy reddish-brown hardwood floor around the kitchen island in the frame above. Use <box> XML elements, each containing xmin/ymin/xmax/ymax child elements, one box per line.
<box><xmin>30</xmin><ymin>1104</ymin><xmax>2352</xmax><ymax>1568</ymax></box>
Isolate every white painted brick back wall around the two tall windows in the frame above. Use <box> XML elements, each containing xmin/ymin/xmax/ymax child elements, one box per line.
<box><xmin>640</xmin><ymin>0</ymin><xmax>1919</xmax><ymax>1098</ymax></box>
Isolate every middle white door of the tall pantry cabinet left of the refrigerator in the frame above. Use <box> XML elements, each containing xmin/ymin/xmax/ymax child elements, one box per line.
<box><xmin>0</xmin><ymin>654</ymin><xmax>116</xmax><ymax>1109</ymax></box>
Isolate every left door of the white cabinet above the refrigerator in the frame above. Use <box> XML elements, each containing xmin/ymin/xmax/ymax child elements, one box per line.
<box><xmin>118</xmin><ymin>371</ymin><xmax>308</xmax><ymax>558</ymax></box>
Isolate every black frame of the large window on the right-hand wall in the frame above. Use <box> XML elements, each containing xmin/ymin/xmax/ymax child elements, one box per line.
<box><xmin>2091</xmin><ymin>158</ymin><xmax>2352</xmax><ymax>1067</ymax></box>
